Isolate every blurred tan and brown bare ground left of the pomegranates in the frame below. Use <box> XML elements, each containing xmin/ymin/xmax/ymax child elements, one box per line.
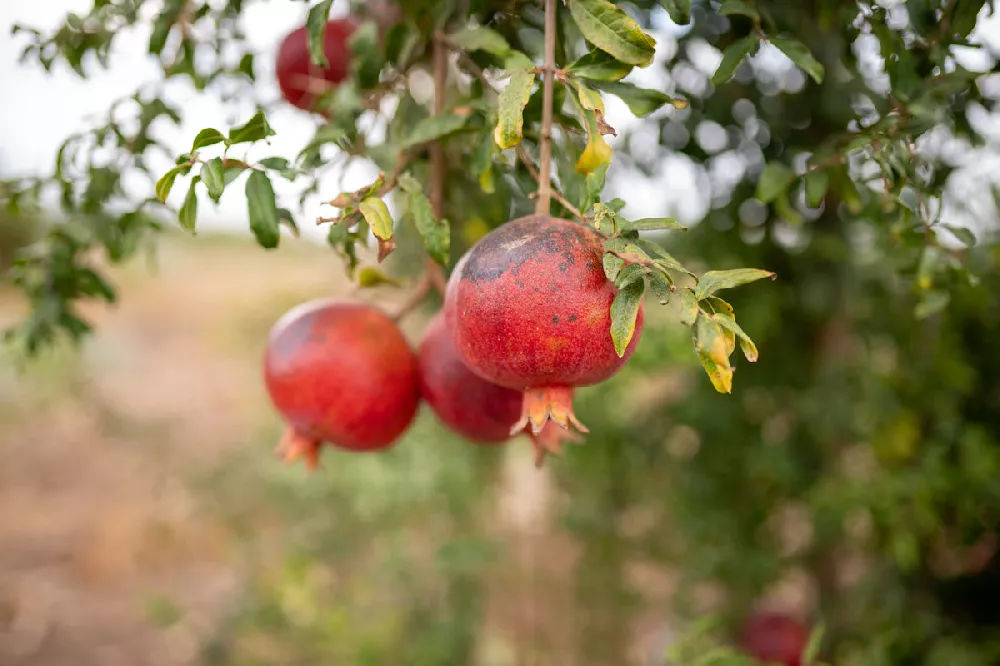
<box><xmin>0</xmin><ymin>239</ymin><xmax>376</xmax><ymax>666</ymax></box>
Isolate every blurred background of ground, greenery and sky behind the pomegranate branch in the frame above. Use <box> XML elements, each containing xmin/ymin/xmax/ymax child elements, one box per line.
<box><xmin>0</xmin><ymin>0</ymin><xmax>1000</xmax><ymax>666</ymax></box>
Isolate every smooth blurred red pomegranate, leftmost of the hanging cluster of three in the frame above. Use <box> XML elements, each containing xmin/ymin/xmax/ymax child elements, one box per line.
<box><xmin>264</xmin><ymin>300</ymin><xmax>420</xmax><ymax>469</ymax></box>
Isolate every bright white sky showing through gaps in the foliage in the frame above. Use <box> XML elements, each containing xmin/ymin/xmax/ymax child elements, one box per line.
<box><xmin>0</xmin><ymin>0</ymin><xmax>1000</xmax><ymax>244</ymax></box>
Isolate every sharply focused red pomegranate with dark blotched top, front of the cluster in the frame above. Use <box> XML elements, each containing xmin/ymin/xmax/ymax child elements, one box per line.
<box><xmin>445</xmin><ymin>215</ymin><xmax>643</xmax><ymax>434</ymax></box>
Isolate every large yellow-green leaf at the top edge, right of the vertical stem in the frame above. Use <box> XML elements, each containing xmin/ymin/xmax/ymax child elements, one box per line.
<box><xmin>569</xmin><ymin>0</ymin><xmax>656</xmax><ymax>67</ymax></box>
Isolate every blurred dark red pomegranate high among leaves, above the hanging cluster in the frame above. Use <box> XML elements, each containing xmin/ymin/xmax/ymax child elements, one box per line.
<box><xmin>274</xmin><ymin>18</ymin><xmax>357</xmax><ymax>111</ymax></box>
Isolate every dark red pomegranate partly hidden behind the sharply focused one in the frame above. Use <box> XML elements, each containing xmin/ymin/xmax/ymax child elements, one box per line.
<box><xmin>417</xmin><ymin>312</ymin><xmax>584</xmax><ymax>465</ymax></box>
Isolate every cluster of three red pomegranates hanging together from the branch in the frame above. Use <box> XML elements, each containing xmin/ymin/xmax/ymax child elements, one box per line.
<box><xmin>264</xmin><ymin>215</ymin><xmax>642</xmax><ymax>467</ymax></box>
